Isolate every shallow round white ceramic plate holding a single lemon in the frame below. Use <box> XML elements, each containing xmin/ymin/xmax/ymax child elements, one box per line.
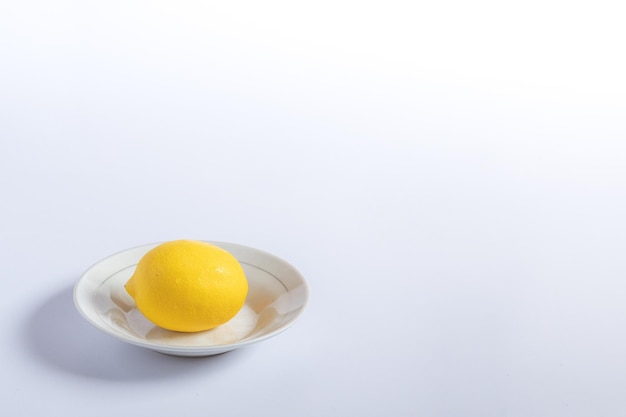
<box><xmin>74</xmin><ymin>242</ymin><xmax>309</xmax><ymax>356</ymax></box>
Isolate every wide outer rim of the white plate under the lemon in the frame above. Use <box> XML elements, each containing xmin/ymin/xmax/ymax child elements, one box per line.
<box><xmin>72</xmin><ymin>239</ymin><xmax>310</xmax><ymax>356</ymax></box>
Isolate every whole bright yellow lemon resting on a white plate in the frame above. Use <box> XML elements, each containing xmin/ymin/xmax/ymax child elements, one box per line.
<box><xmin>124</xmin><ymin>240</ymin><xmax>248</xmax><ymax>332</ymax></box>
